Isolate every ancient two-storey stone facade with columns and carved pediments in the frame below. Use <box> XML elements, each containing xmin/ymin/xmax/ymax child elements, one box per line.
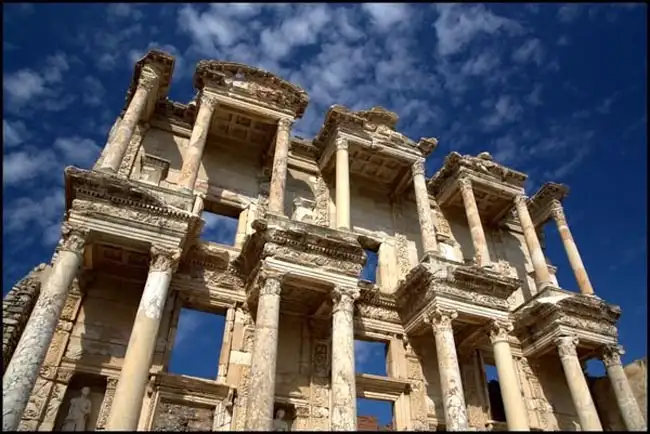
<box><xmin>3</xmin><ymin>51</ymin><xmax>645</xmax><ymax>431</ymax></box>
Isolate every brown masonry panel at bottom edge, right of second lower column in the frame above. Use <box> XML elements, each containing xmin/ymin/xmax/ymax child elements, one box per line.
<box><xmin>151</xmin><ymin>399</ymin><xmax>214</xmax><ymax>431</ymax></box>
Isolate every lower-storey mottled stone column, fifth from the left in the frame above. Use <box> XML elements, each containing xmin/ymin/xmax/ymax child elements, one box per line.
<box><xmin>425</xmin><ymin>308</ymin><xmax>469</xmax><ymax>431</ymax></box>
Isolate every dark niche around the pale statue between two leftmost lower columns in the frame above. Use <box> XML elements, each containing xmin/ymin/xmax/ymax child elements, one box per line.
<box><xmin>54</xmin><ymin>373</ymin><xmax>106</xmax><ymax>431</ymax></box>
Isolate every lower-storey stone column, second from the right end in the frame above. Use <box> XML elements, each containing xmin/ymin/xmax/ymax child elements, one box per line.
<box><xmin>554</xmin><ymin>336</ymin><xmax>603</xmax><ymax>431</ymax></box>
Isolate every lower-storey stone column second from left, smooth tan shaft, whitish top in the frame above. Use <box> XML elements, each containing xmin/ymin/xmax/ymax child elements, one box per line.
<box><xmin>106</xmin><ymin>246</ymin><xmax>180</xmax><ymax>431</ymax></box>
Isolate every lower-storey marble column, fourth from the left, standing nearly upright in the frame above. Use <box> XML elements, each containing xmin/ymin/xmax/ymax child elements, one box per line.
<box><xmin>330</xmin><ymin>287</ymin><xmax>359</xmax><ymax>431</ymax></box>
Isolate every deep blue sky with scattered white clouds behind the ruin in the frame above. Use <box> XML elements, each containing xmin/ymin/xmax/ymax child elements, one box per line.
<box><xmin>2</xmin><ymin>3</ymin><xmax>647</xmax><ymax>426</ymax></box>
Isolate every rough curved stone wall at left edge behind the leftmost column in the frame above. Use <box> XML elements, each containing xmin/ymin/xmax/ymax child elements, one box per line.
<box><xmin>2</xmin><ymin>264</ymin><xmax>46</xmax><ymax>373</ymax></box>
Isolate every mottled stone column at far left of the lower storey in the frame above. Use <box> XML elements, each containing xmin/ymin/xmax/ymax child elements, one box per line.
<box><xmin>2</xmin><ymin>222</ymin><xmax>88</xmax><ymax>431</ymax></box>
